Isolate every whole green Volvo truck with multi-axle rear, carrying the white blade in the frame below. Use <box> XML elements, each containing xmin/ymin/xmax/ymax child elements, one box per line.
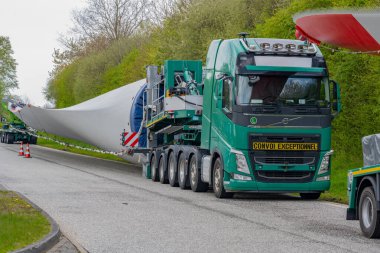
<box><xmin>131</xmin><ymin>33</ymin><xmax>341</xmax><ymax>199</ymax></box>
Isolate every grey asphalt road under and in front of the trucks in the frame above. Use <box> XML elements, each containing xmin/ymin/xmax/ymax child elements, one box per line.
<box><xmin>0</xmin><ymin>144</ymin><xmax>380</xmax><ymax>253</ymax></box>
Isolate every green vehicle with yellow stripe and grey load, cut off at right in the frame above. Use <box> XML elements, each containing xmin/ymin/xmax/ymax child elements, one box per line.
<box><xmin>347</xmin><ymin>134</ymin><xmax>380</xmax><ymax>238</ymax></box>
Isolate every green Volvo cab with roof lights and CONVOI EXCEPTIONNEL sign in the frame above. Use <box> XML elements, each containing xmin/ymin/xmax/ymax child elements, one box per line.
<box><xmin>201</xmin><ymin>38</ymin><xmax>340</xmax><ymax>199</ymax></box>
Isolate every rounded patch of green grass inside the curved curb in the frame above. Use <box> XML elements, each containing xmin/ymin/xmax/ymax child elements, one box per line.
<box><xmin>0</xmin><ymin>191</ymin><xmax>51</xmax><ymax>253</ymax></box>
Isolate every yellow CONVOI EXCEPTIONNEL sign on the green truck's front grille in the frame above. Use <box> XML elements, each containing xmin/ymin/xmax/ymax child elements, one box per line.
<box><xmin>253</xmin><ymin>142</ymin><xmax>318</xmax><ymax>151</ymax></box>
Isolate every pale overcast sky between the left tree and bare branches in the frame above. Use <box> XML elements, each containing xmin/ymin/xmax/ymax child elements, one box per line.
<box><xmin>0</xmin><ymin>0</ymin><xmax>86</xmax><ymax>106</ymax></box>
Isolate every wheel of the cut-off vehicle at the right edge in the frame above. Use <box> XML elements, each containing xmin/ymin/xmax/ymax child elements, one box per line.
<box><xmin>359</xmin><ymin>187</ymin><xmax>380</xmax><ymax>238</ymax></box>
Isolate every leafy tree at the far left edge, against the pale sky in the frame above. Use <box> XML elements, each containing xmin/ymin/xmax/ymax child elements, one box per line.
<box><xmin>0</xmin><ymin>36</ymin><xmax>18</xmax><ymax>97</ymax></box>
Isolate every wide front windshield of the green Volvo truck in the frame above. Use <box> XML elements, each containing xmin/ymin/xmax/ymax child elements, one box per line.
<box><xmin>236</xmin><ymin>75</ymin><xmax>329</xmax><ymax>106</ymax></box>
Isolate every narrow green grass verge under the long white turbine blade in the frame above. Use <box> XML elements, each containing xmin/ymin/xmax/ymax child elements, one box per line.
<box><xmin>37</xmin><ymin>133</ymin><xmax>128</xmax><ymax>163</ymax></box>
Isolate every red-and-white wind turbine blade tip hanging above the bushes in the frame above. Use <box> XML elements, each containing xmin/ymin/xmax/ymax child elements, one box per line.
<box><xmin>294</xmin><ymin>10</ymin><xmax>380</xmax><ymax>51</ymax></box>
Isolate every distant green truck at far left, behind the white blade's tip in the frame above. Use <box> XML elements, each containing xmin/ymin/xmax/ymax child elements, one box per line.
<box><xmin>0</xmin><ymin>100</ymin><xmax>37</xmax><ymax>144</ymax></box>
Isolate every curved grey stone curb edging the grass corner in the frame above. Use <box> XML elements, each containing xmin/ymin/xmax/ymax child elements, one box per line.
<box><xmin>11</xmin><ymin>192</ymin><xmax>61</xmax><ymax>253</ymax></box>
